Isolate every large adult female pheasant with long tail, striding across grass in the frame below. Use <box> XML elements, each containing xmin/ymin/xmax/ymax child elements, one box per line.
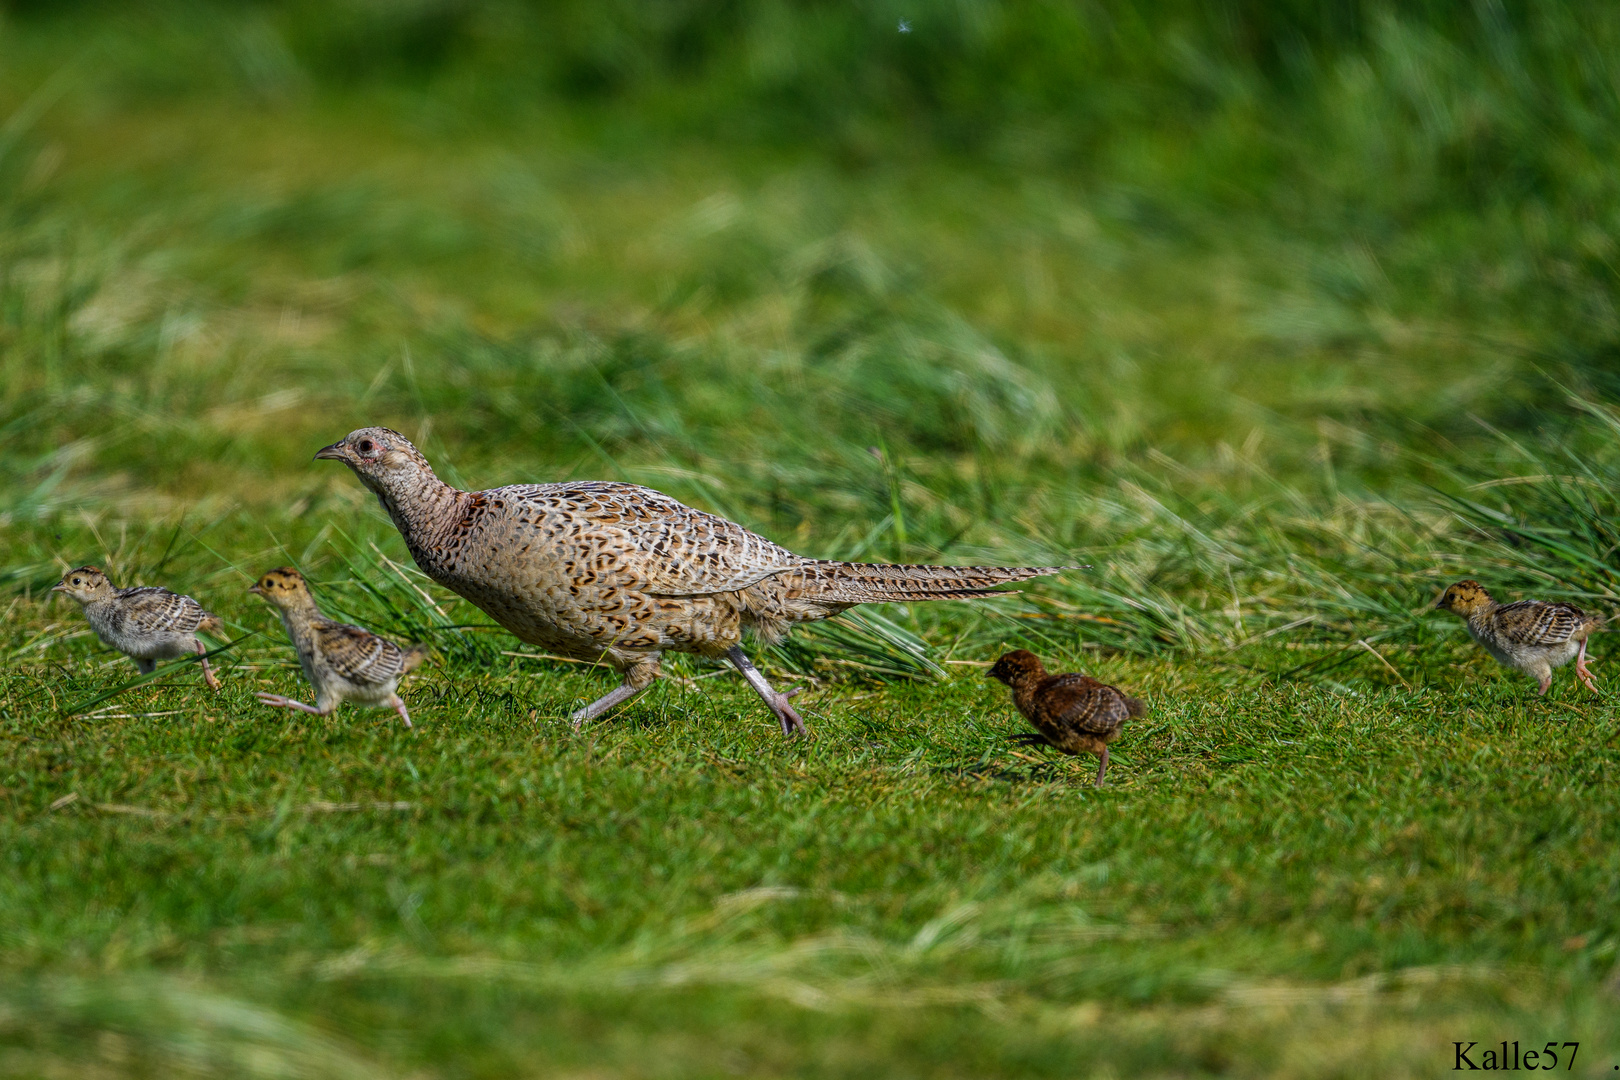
<box><xmin>316</xmin><ymin>427</ymin><xmax>1061</xmax><ymax>735</ymax></box>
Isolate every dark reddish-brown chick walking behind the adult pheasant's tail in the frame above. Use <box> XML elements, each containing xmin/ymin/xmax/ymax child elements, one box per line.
<box><xmin>988</xmin><ymin>649</ymin><xmax>1147</xmax><ymax>787</ymax></box>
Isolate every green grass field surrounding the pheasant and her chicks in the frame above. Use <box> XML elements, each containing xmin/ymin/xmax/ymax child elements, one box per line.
<box><xmin>9</xmin><ymin>0</ymin><xmax>1620</xmax><ymax>1077</ymax></box>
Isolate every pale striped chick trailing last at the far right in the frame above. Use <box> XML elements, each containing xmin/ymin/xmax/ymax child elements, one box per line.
<box><xmin>1435</xmin><ymin>581</ymin><xmax>1604</xmax><ymax>693</ymax></box>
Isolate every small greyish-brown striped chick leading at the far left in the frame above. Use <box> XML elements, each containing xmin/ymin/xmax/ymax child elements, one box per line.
<box><xmin>50</xmin><ymin>567</ymin><xmax>225</xmax><ymax>690</ymax></box>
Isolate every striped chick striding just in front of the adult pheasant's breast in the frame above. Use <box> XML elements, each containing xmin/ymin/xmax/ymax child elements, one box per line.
<box><xmin>248</xmin><ymin>567</ymin><xmax>428</xmax><ymax>727</ymax></box>
